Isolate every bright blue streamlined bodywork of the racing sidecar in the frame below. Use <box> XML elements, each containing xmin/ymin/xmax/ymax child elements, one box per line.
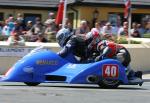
<box><xmin>1</xmin><ymin>47</ymin><xmax>141</xmax><ymax>84</ymax></box>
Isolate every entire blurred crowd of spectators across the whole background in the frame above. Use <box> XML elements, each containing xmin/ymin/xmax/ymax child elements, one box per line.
<box><xmin>0</xmin><ymin>12</ymin><xmax>150</xmax><ymax>45</ymax></box>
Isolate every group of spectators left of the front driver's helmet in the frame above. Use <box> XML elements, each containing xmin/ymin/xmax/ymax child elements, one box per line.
<box><xmin>0</xmin><ymin>13</ymin><xmax>58</xmax><ymax>45</ymax></box>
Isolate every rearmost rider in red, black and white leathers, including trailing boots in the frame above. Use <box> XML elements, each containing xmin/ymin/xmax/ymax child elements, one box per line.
<box><xmin>95</xmin><ymin>40</ymin><xmax>142</xmax><ymax>82</ymax></box>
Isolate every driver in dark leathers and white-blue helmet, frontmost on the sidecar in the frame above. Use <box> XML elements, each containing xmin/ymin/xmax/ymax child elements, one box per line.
<box><xmin>56</xmin><ymin>28</ymin><xmax>87</xmax><ymax>62</ymax></box>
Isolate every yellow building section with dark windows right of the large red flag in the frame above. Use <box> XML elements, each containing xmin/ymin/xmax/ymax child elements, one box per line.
<box><xmin>68</xmin><ymin>0</ymin><xmax>150</xmax><ymax>27</ymax></box>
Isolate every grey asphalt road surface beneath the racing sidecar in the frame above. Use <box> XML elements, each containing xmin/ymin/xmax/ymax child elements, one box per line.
<box><xmin>0</xmin><ymin>82</ymin><xmax>150</xmax><ymax>103</ymax></box>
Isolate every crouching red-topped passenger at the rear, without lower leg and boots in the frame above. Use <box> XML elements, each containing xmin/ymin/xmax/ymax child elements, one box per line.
<box><xmin>96</xmin><ymin>40</ymin><xmax>131</xmax><ymax>67</ymax></box>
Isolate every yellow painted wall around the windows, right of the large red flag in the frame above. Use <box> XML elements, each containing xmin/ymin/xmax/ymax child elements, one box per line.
<box><xmin>74</xmin><ymin>6</ymin><xmax>150</xmax><ymax>26</ymax></box>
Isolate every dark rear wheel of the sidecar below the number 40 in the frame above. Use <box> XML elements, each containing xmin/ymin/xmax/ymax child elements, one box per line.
<box><xmin>98</xmin><ymin>79</ymin><xmax>120</xmax><ymax>89</ymax></box>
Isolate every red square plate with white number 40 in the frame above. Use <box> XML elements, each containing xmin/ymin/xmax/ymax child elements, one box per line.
<box><xmin>102</xmin><ymin>64</ymin><xmax>119</xmax><ymax>78</ymax></box>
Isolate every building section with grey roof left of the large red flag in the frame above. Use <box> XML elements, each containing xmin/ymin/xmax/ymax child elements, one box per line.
<box><xmin>0</xmin><ymin>0</ymin><xmax>59</xmax><ymax>21</ymax></box>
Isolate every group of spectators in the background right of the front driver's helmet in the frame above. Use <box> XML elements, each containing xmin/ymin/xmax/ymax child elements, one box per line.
<box><xmin>75</xmin><ymin>18</ymin><xmax>150</xmax><ymax>41</ymax></box>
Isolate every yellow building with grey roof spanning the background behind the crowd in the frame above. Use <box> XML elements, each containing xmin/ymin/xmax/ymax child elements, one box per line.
<box><xmin>0</xmin><ymin>0</ymin><xmax>150</xmax><ymax>28</ymax></box>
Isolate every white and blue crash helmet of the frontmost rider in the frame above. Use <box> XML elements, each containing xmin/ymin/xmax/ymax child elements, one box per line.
<box><xmin>56</xmin><ymin>28</ymin><xmax>72</xmax><ymax>47</ymax></box>
